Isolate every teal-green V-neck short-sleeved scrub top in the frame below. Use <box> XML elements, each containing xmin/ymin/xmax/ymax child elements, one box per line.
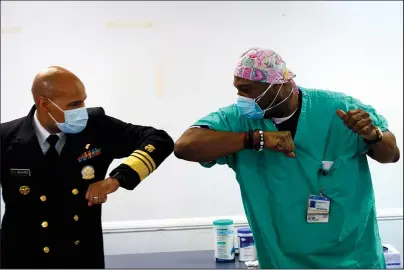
<box><xmin>195</xmin><ymin>87</ymin><xmax>388</xmax><ymax>269</ymax></box>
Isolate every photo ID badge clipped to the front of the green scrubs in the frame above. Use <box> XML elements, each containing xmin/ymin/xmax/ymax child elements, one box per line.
<box><xmin>307</xmin><ymin>195</ymin><xmax>331</xmax><ymax>223</ymax></box>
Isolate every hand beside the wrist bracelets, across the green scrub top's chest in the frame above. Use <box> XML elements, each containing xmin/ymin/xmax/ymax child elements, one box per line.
<box><xmin>264</xmin><ymin>131</ymin><xmax>296</xmax><ymax>158</ymax></box>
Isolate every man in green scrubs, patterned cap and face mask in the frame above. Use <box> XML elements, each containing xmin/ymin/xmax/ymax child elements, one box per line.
<box><xmin>174</xmin><ymin>48</ymin><xmax>400</xmax><ymax>268</ymax></box>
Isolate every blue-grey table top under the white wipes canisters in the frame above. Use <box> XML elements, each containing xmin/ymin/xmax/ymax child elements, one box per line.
<box><xmin>105</xmin><ymin>250</ymin><xmax>247</xmax><ymax>269</ymax></box>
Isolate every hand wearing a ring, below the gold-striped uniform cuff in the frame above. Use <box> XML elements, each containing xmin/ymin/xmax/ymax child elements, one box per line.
<box><xmin>86</xmin><ymin>177</ymin><xmax>119</xmax><ymax>206</ymax></box>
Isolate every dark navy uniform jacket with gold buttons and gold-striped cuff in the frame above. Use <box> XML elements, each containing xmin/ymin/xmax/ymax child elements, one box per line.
<box><xmin>0</xmin><ymin>107</ymin><xmax>174</xmax><ymax>268</ymax></box>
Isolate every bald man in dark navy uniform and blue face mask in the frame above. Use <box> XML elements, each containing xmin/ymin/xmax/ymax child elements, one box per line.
<box><xmin>1</xmin><ymin>67</ymin><xmax>174</xmax><ymax>268</ymax></box>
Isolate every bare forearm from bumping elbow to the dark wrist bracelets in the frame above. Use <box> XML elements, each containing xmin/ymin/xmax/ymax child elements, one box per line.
<box><xmin>174</xmin><ymin>128</ymin><xmax>244</xmax><ymax>162</ymax></box>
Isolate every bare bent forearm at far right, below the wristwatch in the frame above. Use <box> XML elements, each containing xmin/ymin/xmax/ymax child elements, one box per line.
<box><xmin>368</xmin><ymin>132</ymin><xmax>400</xmax><ymax>163</ymax></box>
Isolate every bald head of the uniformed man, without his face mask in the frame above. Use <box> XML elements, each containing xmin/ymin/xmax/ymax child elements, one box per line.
<box><xmin>32</xmin><ymin>66</ymin><xmax>87</xmax><ymax>132</ymax></box>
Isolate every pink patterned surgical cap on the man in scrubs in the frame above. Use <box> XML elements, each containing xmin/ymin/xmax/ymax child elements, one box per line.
<box><xmin>234</xmin><ymin>48</ymin><xmax>297</xmax><ymax>91</ymax></box>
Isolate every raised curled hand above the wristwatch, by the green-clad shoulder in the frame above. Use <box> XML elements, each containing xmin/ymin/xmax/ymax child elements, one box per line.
<box><xmin>337</xmin><ymin>109</ymin><xmax>377</xmax><ymax>141</ymax></box>
